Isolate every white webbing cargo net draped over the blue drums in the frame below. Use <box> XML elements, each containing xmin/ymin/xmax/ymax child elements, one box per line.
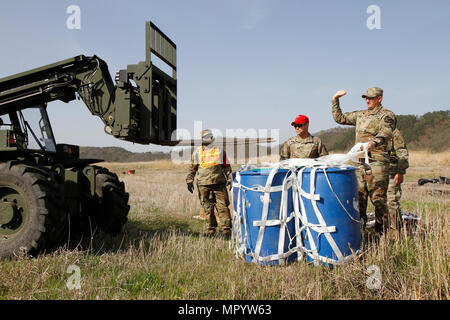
<box><xmin>231</xmin><ymin>143</ymin><xmax>369</xmax><ymax>265</ymax></box>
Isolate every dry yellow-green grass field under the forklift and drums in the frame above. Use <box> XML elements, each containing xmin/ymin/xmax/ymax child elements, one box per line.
<box><xmin>0</xmin><ymin>152</ymin><xmax>450</xmax><ymax>300</ymax></box>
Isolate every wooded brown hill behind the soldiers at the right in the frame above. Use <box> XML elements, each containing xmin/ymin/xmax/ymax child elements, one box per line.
<box><xmin>314</xmin><ymin>110</ymin><xmax>450</xmax><ymax>152</ymax></box>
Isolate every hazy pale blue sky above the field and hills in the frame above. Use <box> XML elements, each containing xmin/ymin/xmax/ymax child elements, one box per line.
<box><xmin>0</xmin><ymin>0</ymin><xmax>450</xmax><ymax>152</ymax></box>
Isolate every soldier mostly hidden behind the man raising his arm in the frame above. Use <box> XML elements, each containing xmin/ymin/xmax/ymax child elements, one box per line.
<box><xmin>387</xmin><ymin>129</ymin><xmax>409</xmax><ymax>229</ymax></box>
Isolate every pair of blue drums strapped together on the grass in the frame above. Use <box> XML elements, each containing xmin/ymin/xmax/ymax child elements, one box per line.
<box><xmin>232</xmin><ymin>167</ymin><xmax>361</xmax><ymax>265</ymax></box>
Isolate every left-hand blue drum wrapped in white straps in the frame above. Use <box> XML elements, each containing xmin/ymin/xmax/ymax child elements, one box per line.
<box><xmin>232</xmin><ymin>169</ymin><xmax>297</xmax><ymax>265</ymax></box>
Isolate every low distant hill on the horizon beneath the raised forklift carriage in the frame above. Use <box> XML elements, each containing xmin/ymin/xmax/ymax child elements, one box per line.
<box><xmin>80</xmin><ymin>147</ymin><xmax>170</xmax><ymax>162</ymax></box>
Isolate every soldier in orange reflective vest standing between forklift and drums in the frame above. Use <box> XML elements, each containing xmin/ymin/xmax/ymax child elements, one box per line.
<box><xmin>186</xmin><ymin>129</ymin><xmax>231</xmax><ymax>235</ymax></box>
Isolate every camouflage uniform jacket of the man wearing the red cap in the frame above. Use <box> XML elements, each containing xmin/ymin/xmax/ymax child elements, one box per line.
<box><xmin>280</xmin><ymin>135</ymin><xmax>328</xmax><ymax>160</ymax></box>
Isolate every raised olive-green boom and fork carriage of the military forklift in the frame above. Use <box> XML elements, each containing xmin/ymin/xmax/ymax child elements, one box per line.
<box><xmin>0</xmin><ymin>22</ymin><xmax>177</xmax><ymax>145</ymax></box>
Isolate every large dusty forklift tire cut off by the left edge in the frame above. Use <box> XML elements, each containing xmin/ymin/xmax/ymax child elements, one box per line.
<box><xmin>0</xmin><ymin>161</ymin><xmax>67</xmax><ymax>259</ymax></box>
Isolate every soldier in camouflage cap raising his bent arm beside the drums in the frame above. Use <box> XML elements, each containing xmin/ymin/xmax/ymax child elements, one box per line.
<box><xmin>332</xmin><ymin>87</ymin><xmax>397</xmax><ymax>233</ymax></box>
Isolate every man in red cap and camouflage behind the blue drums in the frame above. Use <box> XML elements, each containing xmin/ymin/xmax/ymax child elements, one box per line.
<box><xmin>280</xmin><ymin>115</ymin><xmax>328</xmax><ymax>161</ymax></box>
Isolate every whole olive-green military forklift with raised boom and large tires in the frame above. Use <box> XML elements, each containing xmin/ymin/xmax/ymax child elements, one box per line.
<box><xmin>0</xmin><ymin>22</ymin><xmax>177</xmax><ymax>258</ymax></box>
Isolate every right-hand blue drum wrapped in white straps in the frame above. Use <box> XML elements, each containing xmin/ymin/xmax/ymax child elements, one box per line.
<box><xmin>297</xmin><ymin>167</ymin><xmax>361</xmax><ymax>265</ymax></box>
